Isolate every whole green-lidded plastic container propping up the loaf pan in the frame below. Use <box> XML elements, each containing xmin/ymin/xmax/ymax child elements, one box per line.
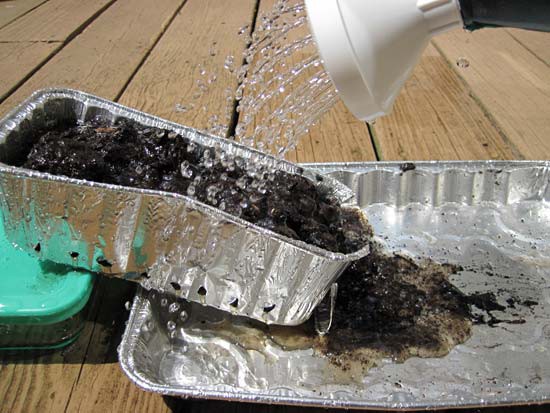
<box><xmin>0</xmin><ymin>215</ymin><xmax>94</xmax><ymax>350</ymax></box>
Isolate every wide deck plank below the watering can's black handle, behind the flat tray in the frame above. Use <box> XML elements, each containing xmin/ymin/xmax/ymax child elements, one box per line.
<box><xmin>435</xmin><ymin>30</ymin><xmax>550</xmax><ymax>159</ymax></box>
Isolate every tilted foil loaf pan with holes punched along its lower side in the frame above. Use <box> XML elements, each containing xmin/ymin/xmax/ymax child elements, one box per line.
<box><xmin>0</xmin><ymin>89</ymin><xmax>374</xmax><ymax>325</ymax></box>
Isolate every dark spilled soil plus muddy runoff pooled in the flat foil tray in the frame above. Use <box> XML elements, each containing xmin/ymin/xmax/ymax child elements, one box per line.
<box><xmin>151</xmin><ymin>243</ymin><xmax>536</xmax><ymax>377</ymax></box>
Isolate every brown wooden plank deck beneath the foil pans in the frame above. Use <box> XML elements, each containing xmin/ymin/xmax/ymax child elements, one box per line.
<box><xmin>0</xmin><ymin>0</ymin><xmax>550</xmax><ymax>413</ymax></box>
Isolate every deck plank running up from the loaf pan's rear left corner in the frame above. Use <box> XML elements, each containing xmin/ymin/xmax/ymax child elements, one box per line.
<box><xmin>0</xmin><ymin>0</ymin><xmax>184</xmax><ymax>115</ymax></box>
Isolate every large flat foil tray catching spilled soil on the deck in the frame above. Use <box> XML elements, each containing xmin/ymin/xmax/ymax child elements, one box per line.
<box><xmin>119</xmin><ymin>162</ymin><xmax>550</xmax><ymax>410</ymax></box>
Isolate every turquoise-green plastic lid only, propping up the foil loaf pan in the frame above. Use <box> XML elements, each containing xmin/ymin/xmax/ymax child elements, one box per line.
<box><xmin>0</xmin><ymin>217</ymin><xmax>93</xmax><ymax>324</ymax></box>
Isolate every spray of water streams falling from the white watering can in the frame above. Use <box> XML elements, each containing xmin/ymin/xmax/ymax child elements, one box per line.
<box><xmin>235</xmin><ymin>0</ymin><xmax>338</xmax><ymax>157</ymax></box>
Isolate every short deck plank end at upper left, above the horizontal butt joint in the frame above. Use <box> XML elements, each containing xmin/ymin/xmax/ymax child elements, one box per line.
<box><xmin>0</xmin><ymin>0</ymin><xmax>114</xmax><ymax>42</ymax></box>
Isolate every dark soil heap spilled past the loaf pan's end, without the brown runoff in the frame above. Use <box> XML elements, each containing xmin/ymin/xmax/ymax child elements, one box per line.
<box><xmin>319</xmin><ymin>243</ymin><xmax>537</xmax><ymax>369</ymax></box>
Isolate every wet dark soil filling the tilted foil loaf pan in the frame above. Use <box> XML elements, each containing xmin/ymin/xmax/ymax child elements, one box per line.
<box><xmin>16</xmin><ymin>119</ymin><xmax>369</xmax><ymax>254</ymax></box>
